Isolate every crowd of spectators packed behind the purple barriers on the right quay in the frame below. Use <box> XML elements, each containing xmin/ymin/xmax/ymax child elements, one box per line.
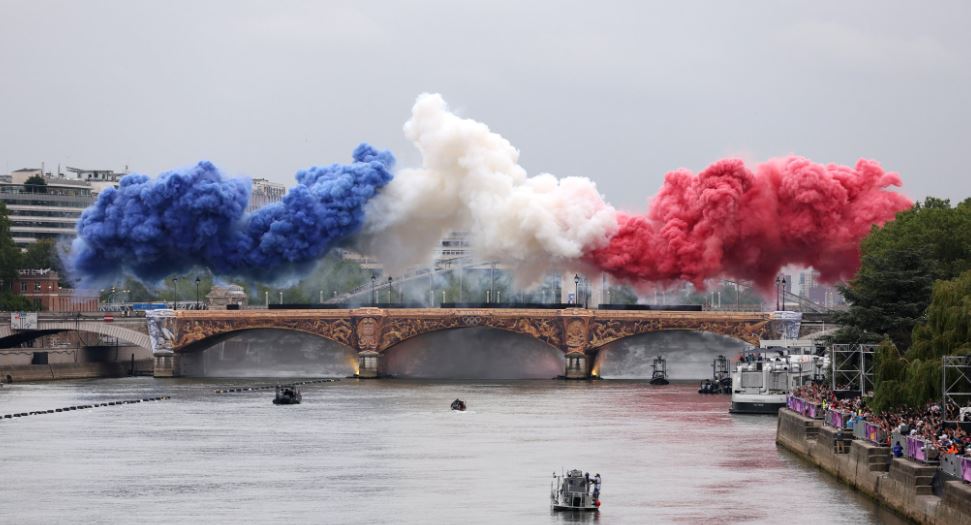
<box><xmin>793</xmin><ymin>384</ymin><xmax>971</xmax><ymax>456</ymax></box>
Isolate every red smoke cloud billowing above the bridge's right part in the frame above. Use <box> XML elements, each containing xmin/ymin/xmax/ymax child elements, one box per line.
<box><xmin>586</xmin><ymin>157</ymin><xmax>912</xmax><ymax>290</ymax></box>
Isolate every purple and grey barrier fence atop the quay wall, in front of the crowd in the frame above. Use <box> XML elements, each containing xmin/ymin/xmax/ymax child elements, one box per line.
<box><xmin>786</xmin><ymin>396</ymin><xmax>971</xmax><ymax>483</ymax></box>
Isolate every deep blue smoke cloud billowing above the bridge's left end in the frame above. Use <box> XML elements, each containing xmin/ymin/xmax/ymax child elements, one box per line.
<box><xmin>66</xmin><ymin>144</ymin><xmax>394</xmax><ymax>284</ymax></box>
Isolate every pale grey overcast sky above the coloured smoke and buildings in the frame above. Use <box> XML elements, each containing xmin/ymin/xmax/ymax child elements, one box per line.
<box><xmin>0</xmin><ymin>0</ymin><xmax>971</xmax><ymax>210</ymax></box>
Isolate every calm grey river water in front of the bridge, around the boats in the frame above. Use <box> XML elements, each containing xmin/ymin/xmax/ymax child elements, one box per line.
<box><xmin>0</xmin><ymin>378</ymin><xmax>904</xmax><ymax>524</ymax></box>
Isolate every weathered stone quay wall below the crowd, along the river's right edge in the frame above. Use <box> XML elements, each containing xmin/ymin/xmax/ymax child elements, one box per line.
<box><xmin>776</xmin><ymin>408</ymin><xmax>971</xmax><ymax>525</ymax></box>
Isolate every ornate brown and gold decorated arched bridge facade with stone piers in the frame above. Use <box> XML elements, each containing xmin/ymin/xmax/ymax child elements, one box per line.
<box><xmin>148</xmin><ymin>308</ymin><xmax>799</xmax><ymax>378</ymax></box>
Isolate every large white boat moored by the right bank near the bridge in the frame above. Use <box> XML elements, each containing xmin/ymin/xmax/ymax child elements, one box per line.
<box><xmin>728</xmin><ymin>341</ymin><xmax>827</xmax><ymax>414</ymax></box>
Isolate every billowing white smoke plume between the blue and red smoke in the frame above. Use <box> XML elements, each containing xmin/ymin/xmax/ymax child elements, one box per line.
<box><xmin>362</xmin><ymin>93</ymin><xmax>617</xmax><ymax>283</ymax></box>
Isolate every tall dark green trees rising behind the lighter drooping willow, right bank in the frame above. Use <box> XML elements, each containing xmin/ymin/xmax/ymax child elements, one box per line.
<box><xmin>835</xmin><ymin>197</ymin><xmax>971</xmax><ymax>349</ymax></box>
